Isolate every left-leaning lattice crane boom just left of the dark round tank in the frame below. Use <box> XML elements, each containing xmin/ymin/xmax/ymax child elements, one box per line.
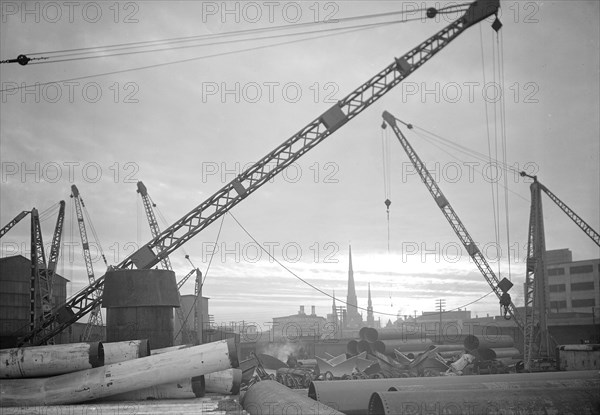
<box><xmin>71</xmin><ymin>185</ymin><xmax>106</xmax><ymax>341</ymax></box>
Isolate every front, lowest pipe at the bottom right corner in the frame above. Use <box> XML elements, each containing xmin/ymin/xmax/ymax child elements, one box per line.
<box><xmin>368</xmin><ymin>385</ymin><xmax>600</xmax><ymax>415</ymax></box>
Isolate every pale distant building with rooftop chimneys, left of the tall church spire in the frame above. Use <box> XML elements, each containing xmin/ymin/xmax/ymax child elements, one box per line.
<box><xmin>272</xmin><ymin>305</ymin><xmax>327</xmax><ymax>341</ymax></box>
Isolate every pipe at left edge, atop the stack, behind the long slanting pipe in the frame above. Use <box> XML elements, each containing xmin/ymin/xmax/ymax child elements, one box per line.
<box><xmin>0</xmin><ymin>342</ymin><xmax>105</xmax><ymax>379</ymax></box>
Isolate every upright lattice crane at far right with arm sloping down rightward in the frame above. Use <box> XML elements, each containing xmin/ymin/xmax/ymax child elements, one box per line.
<box><xmin>520</xmin><ymin>172</ymin><xmax>600</xmax><ymax>371</ymax></box>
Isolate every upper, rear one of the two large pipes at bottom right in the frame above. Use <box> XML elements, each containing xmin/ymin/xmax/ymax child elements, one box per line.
<box><xmin>308</xmin><ymin>371</ymin><xmax>600</xmax><ymax>415</ymax></box>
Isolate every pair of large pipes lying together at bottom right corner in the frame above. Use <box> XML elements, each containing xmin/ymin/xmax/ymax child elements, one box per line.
<box><xmin>310</xmin><ymin>370</ymin><xmax>600</xmax><ymax>415</ymax></box>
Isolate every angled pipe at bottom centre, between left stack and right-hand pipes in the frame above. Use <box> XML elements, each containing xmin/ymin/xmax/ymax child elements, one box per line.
<box><xmin>242</xmin><ymin>380</ymin><xmax>343</xmax><ymax>415</ymax></box>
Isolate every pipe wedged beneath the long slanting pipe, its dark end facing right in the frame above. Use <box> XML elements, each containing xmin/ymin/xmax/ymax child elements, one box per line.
<box><xmin>96</xmin><ymin>375</ymin><xmax>205</xmax><ymax>401</ymax></box>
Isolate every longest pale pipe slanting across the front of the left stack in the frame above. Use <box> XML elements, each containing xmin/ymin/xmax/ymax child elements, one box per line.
<box><xmin>0</xmin><ymin>339</ymin><xmax>238</xmax><ymax>406</ymax></box>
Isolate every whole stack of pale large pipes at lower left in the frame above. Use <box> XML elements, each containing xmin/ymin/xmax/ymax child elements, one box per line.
<box><xmin>0</xmin><ymin>339</ymin><xmax>241</xmax><ymax>407</ymax></box>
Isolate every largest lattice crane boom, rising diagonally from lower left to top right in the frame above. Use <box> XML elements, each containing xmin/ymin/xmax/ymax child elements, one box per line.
<box><xmin>19</xmin><ymin>0</ymin><xmax>500</xmax><ymax>346</ymax></box>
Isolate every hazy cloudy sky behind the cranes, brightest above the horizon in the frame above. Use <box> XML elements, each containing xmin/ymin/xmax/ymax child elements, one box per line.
<box><xmin>0</xmin><ymin>1</ymin><xmax>600</xmax><ymax>326</ymax></box>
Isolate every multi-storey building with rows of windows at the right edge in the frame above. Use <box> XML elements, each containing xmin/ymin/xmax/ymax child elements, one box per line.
<box><xmin>546</xmin><ymin>249</ymin><xmax>600</xmax><ymax>314</ymax></box>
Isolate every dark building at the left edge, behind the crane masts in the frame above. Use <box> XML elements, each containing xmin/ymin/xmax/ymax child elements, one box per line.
<box><xmin>0</xmin><ymin>255</ymin><xmax>70</xmax><ymax>348</ymax></box>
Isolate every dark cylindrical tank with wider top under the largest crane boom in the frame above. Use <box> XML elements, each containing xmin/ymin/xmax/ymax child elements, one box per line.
<box><xmin>102</xmin><ymin>269</ymin><xmax>179</xmax><ymax>349</ymax></box>
